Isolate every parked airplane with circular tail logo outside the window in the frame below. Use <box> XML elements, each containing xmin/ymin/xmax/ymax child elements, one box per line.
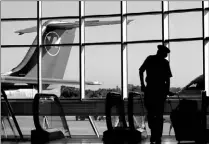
<box><xmin>1</xmin><ymin>20</ymin><xmax>131</xmax><ymax>98</ymax></box>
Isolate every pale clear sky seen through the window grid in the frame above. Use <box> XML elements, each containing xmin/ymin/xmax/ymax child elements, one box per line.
<box><xmin>1</xmin><ymin>1</ymin><xmax>206</xmax><ymax>89</ymax></box>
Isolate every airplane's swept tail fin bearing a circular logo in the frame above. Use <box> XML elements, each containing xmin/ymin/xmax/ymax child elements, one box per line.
<box><xmin>10</xmin><ymin>20</ymin><xmax>75</xmax><ymax>82</ymax></box>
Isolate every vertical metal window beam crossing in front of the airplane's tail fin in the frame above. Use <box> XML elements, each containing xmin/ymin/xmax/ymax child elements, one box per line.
<box><xmin>37</xmin><ymin>1</ymin><xmax>42</xmax><ymax>93</ymax></box>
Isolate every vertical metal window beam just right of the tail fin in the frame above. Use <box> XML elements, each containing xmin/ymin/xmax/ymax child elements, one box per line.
<box><xmin>79</xmin><ymin>1</ymin><xmax>85</xmax><ymax>100</ymax></box>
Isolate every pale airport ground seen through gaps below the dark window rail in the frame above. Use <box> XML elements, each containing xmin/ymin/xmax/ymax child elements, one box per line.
<box><xmin>1</xmin><ymin>116</ymin><xmax>209</xmax><ymax>144</ymax></box>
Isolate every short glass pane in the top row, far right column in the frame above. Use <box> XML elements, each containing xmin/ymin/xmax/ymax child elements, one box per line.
<box><xmin>169</xmin><ymin>1</ymin><xmax>202</xmax><ymax>10</ymax></box>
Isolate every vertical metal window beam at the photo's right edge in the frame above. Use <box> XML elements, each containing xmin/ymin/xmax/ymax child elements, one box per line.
<box><xmin>202</xmin><ymin>1</ymin><xmax>209</xmax><ymax>96</ymax></box>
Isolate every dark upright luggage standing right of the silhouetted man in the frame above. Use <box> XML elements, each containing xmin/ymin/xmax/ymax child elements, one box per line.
<box><xmin>170</xmin><ymin>99</ymin><xmax>202</xmax><ymax>143</ymax></box>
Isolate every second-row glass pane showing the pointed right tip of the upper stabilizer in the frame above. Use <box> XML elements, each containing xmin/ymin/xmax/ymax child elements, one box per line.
<box><xmin>127</xmin><ymin>15</ymin><xmax>162</xmax><ymax>41</ymax></box>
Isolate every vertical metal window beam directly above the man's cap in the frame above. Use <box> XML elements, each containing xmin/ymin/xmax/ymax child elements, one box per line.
<box><xmin>162</xmin><ymin>1</ymin><xmax>170</xmax><ymax>61</ymax></box>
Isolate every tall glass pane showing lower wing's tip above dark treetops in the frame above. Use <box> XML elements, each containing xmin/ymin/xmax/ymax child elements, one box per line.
<box><xmin>85</xmin><ymin>45</ymin><xmax>121</xmax><ymax>98</ymax></box>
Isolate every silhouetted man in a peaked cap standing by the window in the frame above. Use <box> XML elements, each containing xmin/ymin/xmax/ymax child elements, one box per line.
<box><xmin>139</xmin><ymin>45</ymin><xmax>172</xmax><ymax>144</ymax></box>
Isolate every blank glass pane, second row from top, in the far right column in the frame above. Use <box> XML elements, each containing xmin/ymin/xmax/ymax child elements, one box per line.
<box><xmin>169</xmin><ymin>12</ymin><xmax>202</xmax><ymax>38</ymax></box>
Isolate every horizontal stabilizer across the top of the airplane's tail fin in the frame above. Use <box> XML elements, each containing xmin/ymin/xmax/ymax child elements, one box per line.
<box><xmin>15</xmin><ymin>20</ymin><xmax>133</xmax><ymax>35</ymax></box>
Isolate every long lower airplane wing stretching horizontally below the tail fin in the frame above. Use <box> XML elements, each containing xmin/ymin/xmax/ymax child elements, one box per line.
<box><xmin>1</xmin><ymin>76</ymin><xmax>101</xmax><ymax>85</ymax></box>
